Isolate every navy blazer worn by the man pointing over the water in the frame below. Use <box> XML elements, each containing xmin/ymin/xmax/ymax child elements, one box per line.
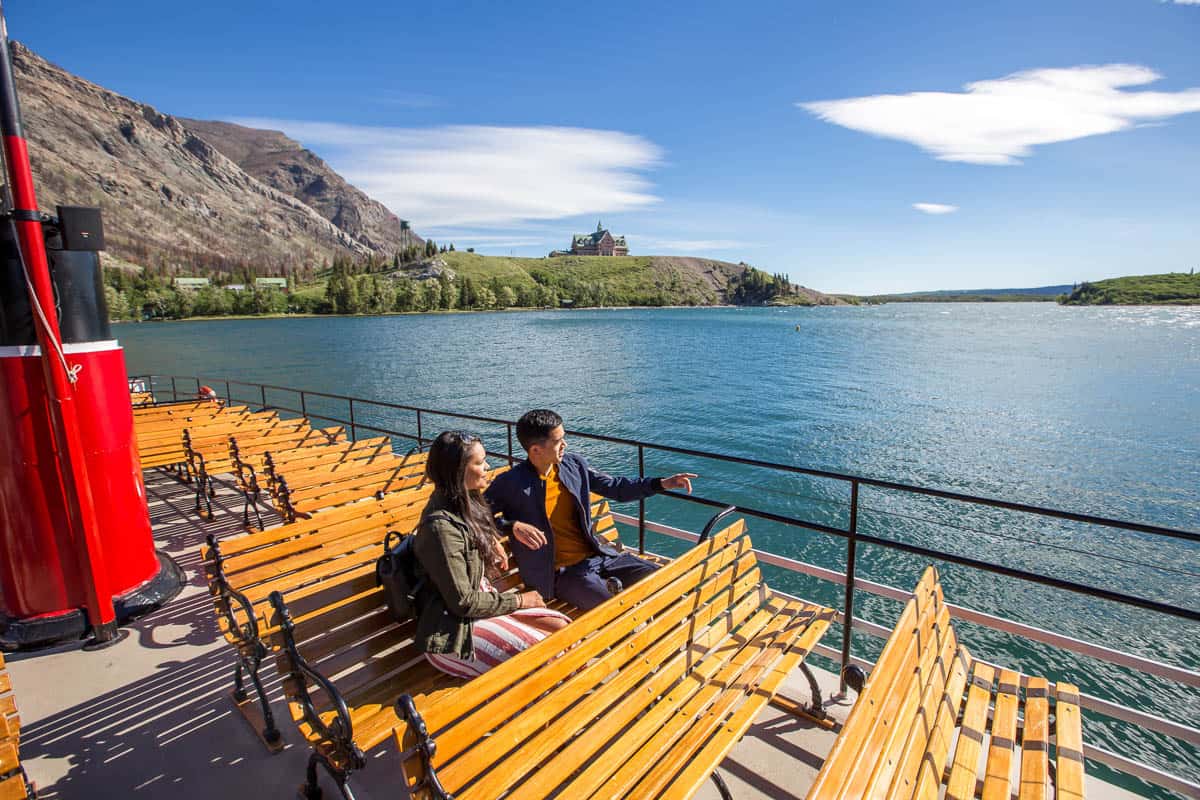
<box><xmin>484</xmin><ymin>453</ymin><xmax>661</xmax><ymax>599</ymax></box>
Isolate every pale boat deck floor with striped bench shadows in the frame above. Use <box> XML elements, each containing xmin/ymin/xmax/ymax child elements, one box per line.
<box><xmin>8</xmin><ymin>473</ymin><xmax>1136</xmax><ymax>800</ymax></box>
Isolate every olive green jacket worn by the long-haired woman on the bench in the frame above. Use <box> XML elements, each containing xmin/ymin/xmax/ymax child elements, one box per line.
<box><xmin>413</xmin><ymin>492</ymin><xmax>520</xmax><ymax>658</ymax></box>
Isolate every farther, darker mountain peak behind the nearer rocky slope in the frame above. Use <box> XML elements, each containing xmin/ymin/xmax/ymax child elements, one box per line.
<box><xmin>180</xmin><ymin>119</ymin><xmax>425</xmax><ymax>255</ymax></box>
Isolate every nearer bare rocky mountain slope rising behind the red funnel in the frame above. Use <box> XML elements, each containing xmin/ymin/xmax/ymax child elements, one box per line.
<box><xmin>5</xmin><ymin>42</ymin><xmax>400</xmax><ymax>273</ymax></box>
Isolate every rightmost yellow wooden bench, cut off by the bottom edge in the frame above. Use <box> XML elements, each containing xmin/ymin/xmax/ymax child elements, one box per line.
<box><xmin>808</xmin><ymin>567</ymin><xmax>1084</xmax><ymax>800</ymax></box>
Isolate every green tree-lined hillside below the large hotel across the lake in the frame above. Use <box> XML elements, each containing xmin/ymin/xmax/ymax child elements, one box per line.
<box><xmin>104</xmin><ymin>251</ymin><xmax>853</xmax><ymax>320</ymax></box>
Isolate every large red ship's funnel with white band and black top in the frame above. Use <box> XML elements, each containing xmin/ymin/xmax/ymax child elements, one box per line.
<box><xmin>0</xmin><ymin>8</ymin><xmax>182</xmax><ymax>646</ymax></box>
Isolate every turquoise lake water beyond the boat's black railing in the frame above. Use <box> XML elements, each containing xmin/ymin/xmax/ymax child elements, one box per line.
<box><xmin>115</xmin><ymin>303</ymin><xmax>1200</xmax><ymax>796</ymax></box>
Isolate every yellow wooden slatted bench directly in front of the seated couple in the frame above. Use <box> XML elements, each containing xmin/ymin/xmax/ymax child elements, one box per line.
<box><xmin>396</xmin><ymin>521</ymin><xmax>834</xmax><ymax>800</ymax></box>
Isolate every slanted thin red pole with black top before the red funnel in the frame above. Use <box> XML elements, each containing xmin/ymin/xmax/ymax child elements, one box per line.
<box><xmin>0</xmin><ymin>6</ymin><xmax>116</xmax><ymax>642</ymax></box>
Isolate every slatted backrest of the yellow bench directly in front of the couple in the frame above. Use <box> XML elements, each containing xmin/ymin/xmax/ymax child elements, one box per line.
<box><xmin>396</xmin><ymin>521</ymin><xmax>781</xmax><ymax>798</ymax></box>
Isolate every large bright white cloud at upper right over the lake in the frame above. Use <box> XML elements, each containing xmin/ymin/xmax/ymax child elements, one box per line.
<box><xmin>797</xmin><ymin>64</ymin><xmax>1200</xmax><ymax>164</ymax></box>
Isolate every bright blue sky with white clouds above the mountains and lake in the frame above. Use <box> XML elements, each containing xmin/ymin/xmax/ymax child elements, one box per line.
<box><xmin>5</xmin><ymin>0</ymin><xmax>1200</xmax><ymax>293</ymax></box>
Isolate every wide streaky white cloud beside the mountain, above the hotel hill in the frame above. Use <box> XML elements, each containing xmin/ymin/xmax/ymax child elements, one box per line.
<box><xmin>235</xmin><ymin>119</ymin><xmax>662</xmax><ymax>230</ymax></box>
